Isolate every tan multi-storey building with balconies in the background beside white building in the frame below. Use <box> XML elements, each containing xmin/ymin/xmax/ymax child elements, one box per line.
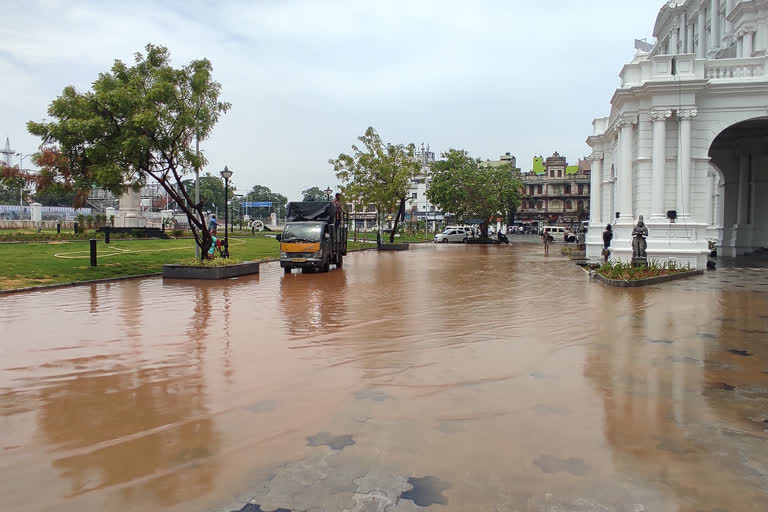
<box><xmin>515</xmin><ymin>152</ymin><xmax>590</xmax><ymax>225</ymax></box>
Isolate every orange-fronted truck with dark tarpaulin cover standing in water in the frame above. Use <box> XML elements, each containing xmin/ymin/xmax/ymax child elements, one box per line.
<box><xmin>277</xmin><ymin>201</ymin><xmax>347</xmax><ymax>274</ymax></box>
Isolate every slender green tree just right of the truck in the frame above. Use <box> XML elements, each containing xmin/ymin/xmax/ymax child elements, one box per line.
<box><xmin>329</xmin><ymin>127</ymin><xmax>421</xmax><ymax>243</ymax></box>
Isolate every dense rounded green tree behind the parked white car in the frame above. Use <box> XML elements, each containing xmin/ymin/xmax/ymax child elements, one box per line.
<box><xmin>427</xmin><ymin>149</ymin><xmax>520</xmax><ymax>238</ymax></box>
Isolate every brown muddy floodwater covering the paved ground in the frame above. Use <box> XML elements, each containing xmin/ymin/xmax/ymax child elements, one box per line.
<box><xmin>0</xmin><ymin>244</ymin><xmax>768</xmax><ymax>512</ymax></box>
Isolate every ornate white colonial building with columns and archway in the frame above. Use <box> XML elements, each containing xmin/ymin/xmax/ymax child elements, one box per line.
<box><xmin>587</xmin><ymin>0</ymin><xmax>768</xmax><ymax>268</ymax></box>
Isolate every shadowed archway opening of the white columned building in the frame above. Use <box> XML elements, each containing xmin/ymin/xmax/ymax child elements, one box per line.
<box><xmin>709</xmin><ymin>117</ymin><xmax>768</xmax><ymax>256</ymax></box>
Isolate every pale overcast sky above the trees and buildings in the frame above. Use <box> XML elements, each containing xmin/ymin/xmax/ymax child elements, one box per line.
<box><xmin>0</xmin><ymin>0</ymin><xmax>664</xmax><ymax>199</ymax></box>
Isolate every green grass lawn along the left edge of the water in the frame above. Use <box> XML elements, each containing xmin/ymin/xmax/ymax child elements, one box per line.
<box><xmin>0</xmin><ymin>236</ymin><xmax>370</xmax><ymax>290</ymax></box>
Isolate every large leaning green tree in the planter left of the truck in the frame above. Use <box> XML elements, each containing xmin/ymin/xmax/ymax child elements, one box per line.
<box><xmin>27</xmin><ymin>44</ymin><xmax>230</xmax><ymax>255</ymax></box>
